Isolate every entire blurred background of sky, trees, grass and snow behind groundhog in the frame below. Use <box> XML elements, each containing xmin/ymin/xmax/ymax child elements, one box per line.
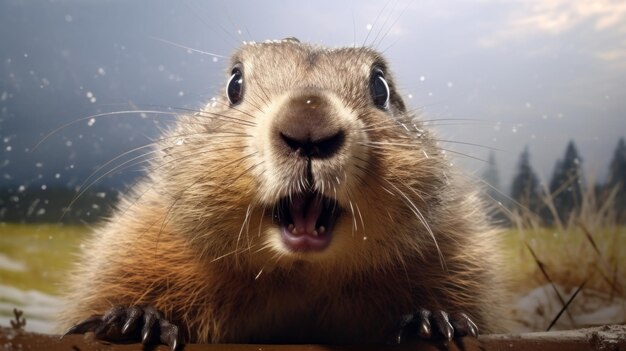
<box><xmin>0</xmin><ymin>0</ymin><xmax>626</xmax><ymax>331</ymax></box>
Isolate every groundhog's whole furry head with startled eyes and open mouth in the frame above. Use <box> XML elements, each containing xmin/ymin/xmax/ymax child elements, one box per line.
<box><xmin>156</xmin><ymin>39</ymin><xmax>446</xmax><ymax>276</ymax></box>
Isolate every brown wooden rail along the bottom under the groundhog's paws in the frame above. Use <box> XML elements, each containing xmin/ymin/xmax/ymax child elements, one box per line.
<box><xmin>0</xmin><ymin>325</ymin><xmax>626</xmax><ymax>351</ymax></box>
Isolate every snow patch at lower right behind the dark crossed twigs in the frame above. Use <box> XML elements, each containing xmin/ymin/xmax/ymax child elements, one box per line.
<box><xmin>514</xmin><ymin>284</ymin><xmax>626</xmax><ymax>332</ymax></box>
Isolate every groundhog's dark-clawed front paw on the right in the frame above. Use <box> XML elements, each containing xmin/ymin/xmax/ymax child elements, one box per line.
<box><xmin>392</xmin><ymin>309</ymin><xmax>478</xmax><ymax>344</ymax></box>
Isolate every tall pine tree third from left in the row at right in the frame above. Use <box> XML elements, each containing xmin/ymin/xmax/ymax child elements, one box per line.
<box><xmin>544</xmin><ymin>141</ymin><xmax>583</xmax><ymax>226</ymax></box>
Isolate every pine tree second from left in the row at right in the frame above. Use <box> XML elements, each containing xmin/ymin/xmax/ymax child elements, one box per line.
<box><xmin>511</xmin><ymin>147</ymin><xmax>539</xmax><ymax>212</ymax></box>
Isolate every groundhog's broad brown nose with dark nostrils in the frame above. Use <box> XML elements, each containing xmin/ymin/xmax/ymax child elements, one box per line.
<box><xmin>273</xmin><ymin>92</ymin><xmax>346</xmax><ymax>158</ymax></box>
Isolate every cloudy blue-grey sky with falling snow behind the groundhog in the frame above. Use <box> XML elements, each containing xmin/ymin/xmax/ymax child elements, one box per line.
<box><xmin>0</xmin><ymin>0</ymin><xmax>626</xmax><ymax>192</ymax></box>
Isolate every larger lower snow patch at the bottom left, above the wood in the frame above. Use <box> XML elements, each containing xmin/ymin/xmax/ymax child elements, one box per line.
<box><xmin>0</xmin><ymin>284</ymin><xmax>61</xmax><ymax>333</ymax></box>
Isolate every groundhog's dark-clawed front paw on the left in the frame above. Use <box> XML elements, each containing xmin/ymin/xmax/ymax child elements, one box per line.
<box><xmin>63</xmin><ymin>306</ymin><xmax>180</xmax><ymax>351</ymax></box>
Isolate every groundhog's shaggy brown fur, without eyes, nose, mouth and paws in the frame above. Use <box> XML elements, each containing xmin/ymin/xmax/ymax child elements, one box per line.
<box><xmin>59</xmin><ymin>40</ymin><xmax>503</xmax><ymax>343</ymax></box>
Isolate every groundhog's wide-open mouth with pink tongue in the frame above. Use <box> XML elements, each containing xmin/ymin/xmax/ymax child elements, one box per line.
<box><xmin>274</xmin><ymin>192</ymin><xmax>341</xmax><ymax>252</ymax></box>
